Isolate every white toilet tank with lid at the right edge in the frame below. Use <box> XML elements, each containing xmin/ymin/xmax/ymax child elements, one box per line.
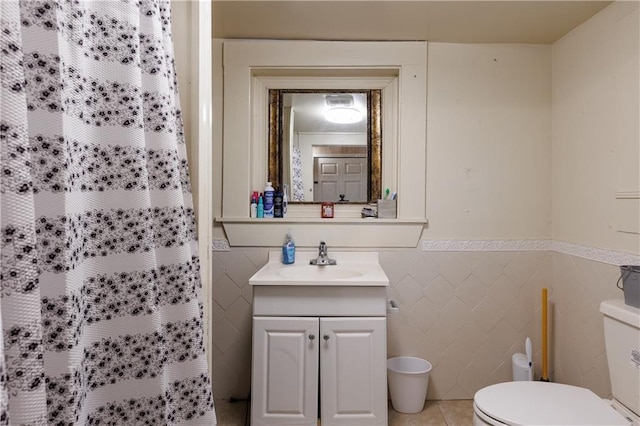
<box><xmin>600</xmin><ymin>299</ymin><xmax>640</xmax><ymax>416</ymax></box>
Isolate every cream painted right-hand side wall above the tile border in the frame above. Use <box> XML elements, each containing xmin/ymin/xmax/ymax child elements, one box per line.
<box><xmin>552</xmin><ymin>2</ymin><xmax>640</xmax><ymax>254</ymax></box>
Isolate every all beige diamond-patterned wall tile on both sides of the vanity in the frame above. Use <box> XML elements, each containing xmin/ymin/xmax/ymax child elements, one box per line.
<box><xmin>212</xmin><ymin>244</ymin><xmax>637</xmax><ymax>400</ymax></box>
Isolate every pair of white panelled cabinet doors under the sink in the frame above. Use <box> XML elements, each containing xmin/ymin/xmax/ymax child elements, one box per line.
<box><xmin>251</xmin><ymin>316</ymin><xmax>387</xmax><ymax>426</ymax></box>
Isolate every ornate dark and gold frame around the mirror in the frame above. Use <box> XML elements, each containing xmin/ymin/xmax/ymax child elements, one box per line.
<box><xmin>268</xmin><ymin>89</ymin><xmax>382</xmax><ymax>204</ymax></box>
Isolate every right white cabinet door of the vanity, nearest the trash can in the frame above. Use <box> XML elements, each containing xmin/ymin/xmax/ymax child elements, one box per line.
<box><xmin>320</xmin><ymin>317</ymin><xmax>387</xmax><ymax>426</ymax></box>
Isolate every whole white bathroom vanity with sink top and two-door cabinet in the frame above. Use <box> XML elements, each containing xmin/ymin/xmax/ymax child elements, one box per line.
<box><xmin>249</xmin><ymin>252</ymin><xmax>389</xmax><ymax>426</ymax></box>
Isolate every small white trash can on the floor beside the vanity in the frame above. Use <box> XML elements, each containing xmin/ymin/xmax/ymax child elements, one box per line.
<box><xmin>387</xmin><ymin>356</ymin><xmax>431</xmax><ymax>414</ymax></box>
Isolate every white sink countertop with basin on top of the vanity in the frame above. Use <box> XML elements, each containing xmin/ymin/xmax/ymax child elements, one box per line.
<box><xmin>249</xmin><ymin>250</ymin><xmax>389</xmax><ymax>286</ymax></box>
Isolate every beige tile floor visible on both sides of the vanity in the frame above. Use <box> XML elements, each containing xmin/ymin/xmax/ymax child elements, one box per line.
<box><xmin>215</xmin><ymin>399</ymin><xmax>473</xmax><ymax>426</ymax></box>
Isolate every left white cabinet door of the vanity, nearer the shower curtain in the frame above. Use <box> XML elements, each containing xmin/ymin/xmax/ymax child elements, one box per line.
<box><xmin>251</xmin><ymin>317</ymin><xmax>319</xmax><ymax>426</ymax></box>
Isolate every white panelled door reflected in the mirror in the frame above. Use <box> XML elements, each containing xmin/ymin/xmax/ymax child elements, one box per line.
<box><xmin>313</xmin><ymin>157</ymin><xmax>367</xmax><ymax>203</ymax></box>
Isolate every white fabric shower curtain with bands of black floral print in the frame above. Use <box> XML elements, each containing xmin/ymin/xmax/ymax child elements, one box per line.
<box><xmin>0</xmin><ymin>0</ymin><xmax>216</xmax><ymax>425</ymax></box>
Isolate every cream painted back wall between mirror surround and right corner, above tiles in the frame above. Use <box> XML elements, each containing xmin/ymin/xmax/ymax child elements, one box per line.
<box><xmin>423</xmin><ymin>43</ymin><xmax>551</xmax><ymax>240</ymax></box>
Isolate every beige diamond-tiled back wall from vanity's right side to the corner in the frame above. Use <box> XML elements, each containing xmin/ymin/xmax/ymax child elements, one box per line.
<box><xmin>382</xmin><ymin>246</ymin><xmax>552</xmax><ymax>399</ymax></box>
